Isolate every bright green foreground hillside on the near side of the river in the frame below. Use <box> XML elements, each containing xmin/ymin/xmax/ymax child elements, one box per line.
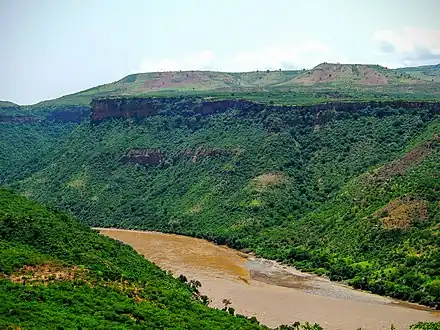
<box><xmin>0</xmin><ymin>188</ymin><xmax>274</xmax><ymax>329</ymax></box>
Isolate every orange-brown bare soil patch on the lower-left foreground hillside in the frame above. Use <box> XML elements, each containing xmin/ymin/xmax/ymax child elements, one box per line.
<box><xmin>5</xmin><ymin>264</ymin><xmax>86</xmax><ymax>284</ymax></box>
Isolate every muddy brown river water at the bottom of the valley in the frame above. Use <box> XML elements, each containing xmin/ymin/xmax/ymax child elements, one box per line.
<box><xmin>99</xmin><ymin>229</ymin><xmax>440</xmax><ymax>330</ymax></box>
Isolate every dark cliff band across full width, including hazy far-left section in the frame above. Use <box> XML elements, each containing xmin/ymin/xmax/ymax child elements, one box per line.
<box><xmin>4</xmin><ymin>97</ymin><xmax>440</xmax><ymax>124</ymax></box>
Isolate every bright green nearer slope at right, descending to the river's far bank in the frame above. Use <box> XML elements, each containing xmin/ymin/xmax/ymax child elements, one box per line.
<box><xmin>257</xmin><ymin>122</ymin><xmax>440</xmax><ymax>308</ymax></box>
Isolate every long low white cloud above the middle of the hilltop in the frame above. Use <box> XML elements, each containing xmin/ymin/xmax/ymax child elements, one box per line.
<box><xmin>138</xmin><ymin>41</ymin><xmax>345</xmax><ymax>72</ymax></box>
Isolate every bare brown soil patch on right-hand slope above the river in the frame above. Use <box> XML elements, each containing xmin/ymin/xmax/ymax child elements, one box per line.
<box><xmin>373</xmin><ymin>198</ymin><xmax>428</xmax><ymax>229</ymax></box>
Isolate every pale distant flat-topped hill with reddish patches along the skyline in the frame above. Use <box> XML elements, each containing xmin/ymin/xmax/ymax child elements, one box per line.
<box><xmin>38</xmin><ymin>63</ymin><xmax>440</xmax><ymax>106</ymax></box>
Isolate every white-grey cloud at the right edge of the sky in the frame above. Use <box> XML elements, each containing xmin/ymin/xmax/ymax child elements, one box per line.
<box><xmin>374</xmin><ymin>27</ymin><xmax>440</xmax><ymax>66</ymax></box>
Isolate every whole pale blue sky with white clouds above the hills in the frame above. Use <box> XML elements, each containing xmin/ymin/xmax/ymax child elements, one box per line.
<box><xmin>0</xmin><ymin>0</ymin><xmax>440</xmax><ymax>104</ymax></box>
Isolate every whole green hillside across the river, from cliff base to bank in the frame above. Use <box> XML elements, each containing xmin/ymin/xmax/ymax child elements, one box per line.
<box><xmin>4</xmin><ymin>99</ymin><xmax>440</xmax><ymax>306</ymax></box>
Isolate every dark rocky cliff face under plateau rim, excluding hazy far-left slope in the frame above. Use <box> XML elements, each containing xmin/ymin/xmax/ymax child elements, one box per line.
<box><xmin>90</xmin><ymin>97</ymin><xmax>440</xmax><ymax>124</ymax></box>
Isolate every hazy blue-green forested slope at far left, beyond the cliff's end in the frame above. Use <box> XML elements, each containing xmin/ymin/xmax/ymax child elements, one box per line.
<box><xmin>0</xmin><ymin>104</ymin><xmax>90</xmax><ymax>184</ymax></box>
